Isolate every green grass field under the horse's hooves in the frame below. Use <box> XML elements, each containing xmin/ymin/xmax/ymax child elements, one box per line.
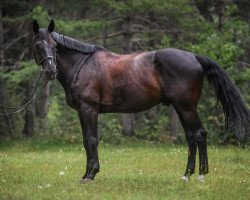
<box><xmin>0</xmin><ymin>140</ymin><xmax>250</xmax><ymax>200</ymax></box>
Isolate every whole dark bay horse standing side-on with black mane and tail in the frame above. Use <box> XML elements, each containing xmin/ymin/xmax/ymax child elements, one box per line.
<box><xmin>33</xmin><ymin>20</ymin><xmax>250</xmax><ymax>182</ymax></box>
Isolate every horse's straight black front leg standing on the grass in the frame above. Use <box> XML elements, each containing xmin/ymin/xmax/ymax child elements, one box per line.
<box><xmin>79</xmin><ymin>104</ymin><xmax>100</xmax><ymax>183</ymax></box>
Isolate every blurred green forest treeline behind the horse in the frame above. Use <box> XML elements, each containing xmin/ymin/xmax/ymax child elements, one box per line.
<box><xmin>0</xmin><ymin>0</ymin><xmax>250</xmax><ymax>143</ymax></box>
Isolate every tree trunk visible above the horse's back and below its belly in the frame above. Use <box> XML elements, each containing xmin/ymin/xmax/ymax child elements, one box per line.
<box><xmin>122</xmin><ymin>16</ymin><xmax>134</xmax><ymax>137</ymax></box>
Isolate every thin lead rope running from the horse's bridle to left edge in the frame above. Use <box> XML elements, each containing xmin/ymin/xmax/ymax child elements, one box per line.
<box><xmin>0</xmin><ymin>71</ymin><xmax>49</xmax><ymax>116</ymax></box>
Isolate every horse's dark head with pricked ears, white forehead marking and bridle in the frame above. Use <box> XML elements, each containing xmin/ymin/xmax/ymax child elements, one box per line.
<box><xmin>33</xmin><ymin>20</ymin><xmax>57</xmax><ymax>80</ymax></box>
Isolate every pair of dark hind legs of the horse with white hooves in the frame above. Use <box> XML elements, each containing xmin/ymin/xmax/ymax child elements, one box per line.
<box><xmin>175</xmin><ymin>105</ymin><xmax>208</xmax><ymax>181</ymax></box>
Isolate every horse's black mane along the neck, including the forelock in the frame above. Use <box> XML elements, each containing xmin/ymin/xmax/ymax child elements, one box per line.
<box><xmin>40</xmin><ymin>29</ymin><xmax>106</xmax><ymax>53</ymax></box>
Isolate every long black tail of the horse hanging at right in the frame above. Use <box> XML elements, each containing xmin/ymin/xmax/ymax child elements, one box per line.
<box><xmin>195</xmin><ymin>55</ymin><xmax>250</xmax><ymax>140</ymax></box>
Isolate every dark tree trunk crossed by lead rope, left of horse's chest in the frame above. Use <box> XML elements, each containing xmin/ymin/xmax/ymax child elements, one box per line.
<box><xmin>23</xmin><ymin>81</ymin><xmax>35</xmax><ymax>138</ymax></box>
